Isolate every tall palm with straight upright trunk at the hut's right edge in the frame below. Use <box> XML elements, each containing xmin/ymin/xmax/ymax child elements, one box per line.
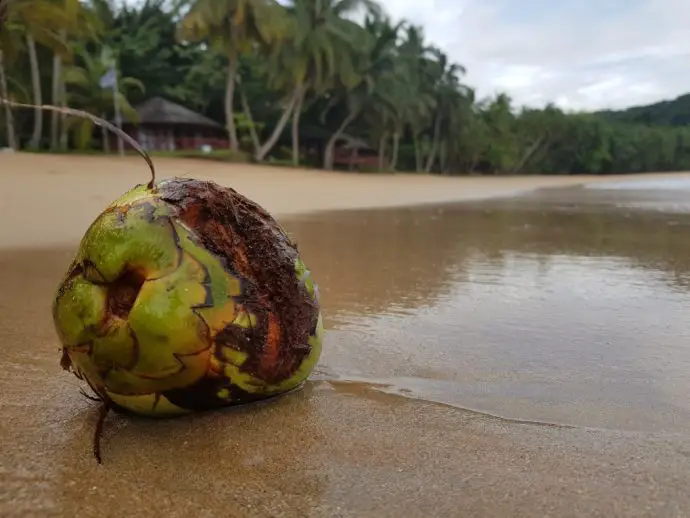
<box><xmin>179</xmin><ymin>0</ymin><xmax>284</xmax><ymax>149</ymax></box>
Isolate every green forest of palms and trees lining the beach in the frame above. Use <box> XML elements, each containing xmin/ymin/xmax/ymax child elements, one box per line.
<box><xmin>0</xmin><ymin>0</ymin><xmax>690</xmax><ymax>175</ymax></box>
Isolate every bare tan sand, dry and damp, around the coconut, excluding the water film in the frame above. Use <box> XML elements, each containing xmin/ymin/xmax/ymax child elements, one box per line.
<box><xmin>0</xmin><ymin>154</ymin><xmax>690</xmax><ymax>518</ymax></box>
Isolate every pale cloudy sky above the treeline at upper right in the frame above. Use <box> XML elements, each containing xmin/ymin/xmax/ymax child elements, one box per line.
<box><xmin>381</xmin><ymin>0</ymin><xmax>690</xmax><ymax>110</ymax></box>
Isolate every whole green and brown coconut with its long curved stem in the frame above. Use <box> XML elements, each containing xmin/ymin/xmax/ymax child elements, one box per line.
<box><xmin>1</xmin><ymin>99</ymin><xmax>323</xmax><ymax>463</ymax></box>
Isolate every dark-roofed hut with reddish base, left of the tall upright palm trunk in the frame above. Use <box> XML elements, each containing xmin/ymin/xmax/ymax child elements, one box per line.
<box><xmin>111</xmin><ymin>97</ymin><xmax>228</xmax><ymax>151</ymax></box>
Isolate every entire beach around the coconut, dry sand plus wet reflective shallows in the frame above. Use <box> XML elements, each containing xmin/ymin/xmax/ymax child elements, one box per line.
<box><xmin>0</xmin><ymin>153</ymin><xmax>690</xmax><ymax>517</ymax></box>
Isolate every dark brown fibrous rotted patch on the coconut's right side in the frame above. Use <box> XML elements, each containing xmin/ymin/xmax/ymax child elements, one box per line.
<box><xmin>157</xmin><ymin>178</ymin><xmax>318</xmax><ymax>383</ymax></box>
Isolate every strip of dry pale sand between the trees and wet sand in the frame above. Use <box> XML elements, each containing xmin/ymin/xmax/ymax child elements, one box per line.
<box><xmin>0</xmin><ymin>153</ymin><xmax>690</xmax><ymax>248</ymax></box>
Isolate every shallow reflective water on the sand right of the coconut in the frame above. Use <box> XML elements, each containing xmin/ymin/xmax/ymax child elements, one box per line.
<box><xmin>288</xmin><ymin>183</ymin><xmax>690</xmax><ymax>431</ymax></box>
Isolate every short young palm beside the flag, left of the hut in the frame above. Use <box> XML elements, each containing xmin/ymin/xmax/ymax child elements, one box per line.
<box><xmin>63</xmin><ymin>46</ymin><xmax>144</xmax><ymax>151</ymax></box>
